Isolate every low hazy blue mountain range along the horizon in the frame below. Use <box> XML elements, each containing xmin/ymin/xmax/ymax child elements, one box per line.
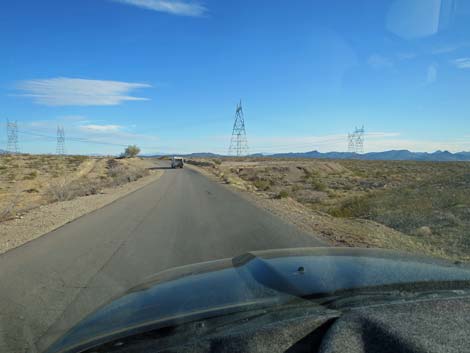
<box><xmin>148</xmin><ymin>150</ymin><xmax>470</xmax><ymax>162</ymax></box>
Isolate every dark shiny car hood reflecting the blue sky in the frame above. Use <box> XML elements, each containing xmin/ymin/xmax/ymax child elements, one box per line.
<box><xmin>47</xmin><ymin>248</ymin><xmax>470</xmax><ymax>352</ymax></box>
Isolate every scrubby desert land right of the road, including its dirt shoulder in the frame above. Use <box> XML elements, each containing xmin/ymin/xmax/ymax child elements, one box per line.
<box><xmin>185</xmin><ymin>158</ymin><xmax>470</xmax><ymax>260</ymax></box>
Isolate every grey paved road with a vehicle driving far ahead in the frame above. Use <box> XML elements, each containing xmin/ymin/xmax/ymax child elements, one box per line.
<box><xmin>0</xmin><ymin>160</ymin><xmax>321</xmax><ymax>352</ymax></box>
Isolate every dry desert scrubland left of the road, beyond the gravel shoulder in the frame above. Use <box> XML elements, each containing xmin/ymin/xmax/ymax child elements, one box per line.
<box><xmin>0</xmin><ymin>154</ymin><xmax>151</xmax><ymax>221</ymax></box>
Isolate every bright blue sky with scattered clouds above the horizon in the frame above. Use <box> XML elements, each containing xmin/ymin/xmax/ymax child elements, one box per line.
<box><xmin>0</xmin><ymin>0</ymin><xmax>470</xmax><ymax>154</ymax></box>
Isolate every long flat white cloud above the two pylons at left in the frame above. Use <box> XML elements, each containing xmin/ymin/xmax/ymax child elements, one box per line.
<box><xmin>18</xmin><ymin>77</ymin><xmax>151</xmax><ymax>106</ymax></box>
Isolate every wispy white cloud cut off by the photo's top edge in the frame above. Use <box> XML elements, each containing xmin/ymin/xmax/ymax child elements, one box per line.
<box><xmin>112</xmin><ymin>0</ymin><xmax>207</xmax><ymax>17</ymax></box>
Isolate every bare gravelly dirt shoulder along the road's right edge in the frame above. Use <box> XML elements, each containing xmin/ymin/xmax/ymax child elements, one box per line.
<box><xmin>185</xmin><ymin>160</ymin><xmax>460</xmax><ymax>260</ymax></box>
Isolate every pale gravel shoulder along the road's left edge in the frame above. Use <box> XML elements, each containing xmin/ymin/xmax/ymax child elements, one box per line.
<box><xmin>0</xmin><ymin>170</ymin><xmax>163</xmax><ymax>254</ymax></box>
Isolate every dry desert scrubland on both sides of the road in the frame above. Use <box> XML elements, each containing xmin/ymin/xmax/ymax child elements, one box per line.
<box><xmin>0</xmin><ymin>155</ymin><xmax>470</xmax><ymax>261</ymax></box>
